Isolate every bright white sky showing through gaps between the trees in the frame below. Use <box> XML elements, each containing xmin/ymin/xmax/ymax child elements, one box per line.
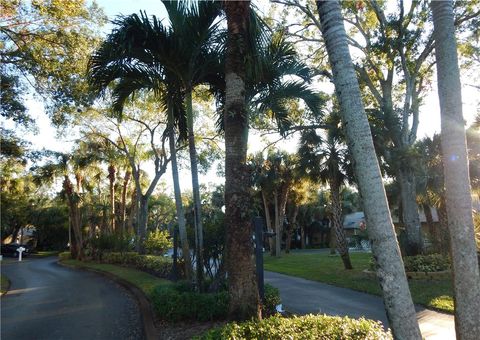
<box><xmin>13</xmin><ymin>0</ymin><xmax>480</xmax><ymax>194</ymax></box>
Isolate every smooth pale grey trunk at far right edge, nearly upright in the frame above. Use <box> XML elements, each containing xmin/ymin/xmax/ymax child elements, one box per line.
<box><xmin>431</xmin><ymin>1</ymin><xmax>480</xmax><ymax>340</ymax></box>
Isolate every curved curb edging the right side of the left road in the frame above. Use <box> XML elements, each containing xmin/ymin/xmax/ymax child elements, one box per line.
<box><xmin>57</xmin><ymin>261</ymin><xmax>158</xmax><ymax>340</ymax></box>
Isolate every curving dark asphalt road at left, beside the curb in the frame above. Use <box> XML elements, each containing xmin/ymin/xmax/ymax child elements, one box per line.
<box><xmin>1</xmin><ymin>257</ymin><xmax>144</xmax><ymax>340</ymax></box>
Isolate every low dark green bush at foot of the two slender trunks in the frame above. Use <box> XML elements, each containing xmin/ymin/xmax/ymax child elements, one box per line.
<box><xmin>150</xmin><ymin>284</ymin><xmax>228</xmax><ymax>322</ymax></box>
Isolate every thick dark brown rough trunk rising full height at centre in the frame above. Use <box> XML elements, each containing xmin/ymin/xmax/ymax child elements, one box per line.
<box><xmin>224</xmin><ymin>1</ymin><xmax>261</xmax><ymax>320</ymax></box>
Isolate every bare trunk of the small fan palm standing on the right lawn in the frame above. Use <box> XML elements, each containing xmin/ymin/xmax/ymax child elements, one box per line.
<box><xmin>329</xmin><ymin>180</ymin><xmax>353</xmax><ymax>269</ymax></box>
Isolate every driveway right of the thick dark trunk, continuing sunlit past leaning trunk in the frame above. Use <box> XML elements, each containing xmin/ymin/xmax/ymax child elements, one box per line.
<box><xmin>265</xmin><ymin>272</ymin><xmax>455</xmax><ymax>340</ymax></box>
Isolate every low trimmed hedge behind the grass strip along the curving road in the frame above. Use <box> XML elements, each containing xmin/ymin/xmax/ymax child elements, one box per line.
<box><xmin>100</xmin><ymin>252</ymin><xmax>172</xmax><ymax>278</ymax></box>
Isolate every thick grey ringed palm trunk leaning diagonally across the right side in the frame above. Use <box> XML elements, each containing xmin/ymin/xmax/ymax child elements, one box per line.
<box><xmin>317</xmin><ymin>1</ymin><xmax>422</xmax><ymax>339</ymax></box>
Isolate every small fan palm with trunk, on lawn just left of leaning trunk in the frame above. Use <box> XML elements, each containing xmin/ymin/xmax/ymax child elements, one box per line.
<box><xmin>299</xmin><ymin>113</ymin><xmax>353</xmax><ymax>269</ymax></box>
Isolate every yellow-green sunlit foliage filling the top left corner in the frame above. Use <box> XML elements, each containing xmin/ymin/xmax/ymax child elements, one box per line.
<box><xmin>0</xmin><ymin>0</ymin><xmax>106</xmax><ymax>126</ymax></box>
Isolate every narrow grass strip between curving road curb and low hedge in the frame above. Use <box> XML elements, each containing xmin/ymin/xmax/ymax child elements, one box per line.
<box><xmin>62</xmin><ymin>260</ymin><xmax>172</xmax><ymax>296</ymax></box>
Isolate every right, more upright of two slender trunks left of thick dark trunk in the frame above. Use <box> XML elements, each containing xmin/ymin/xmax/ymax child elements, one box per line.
<box><xmin>185</xmin><ymin>91</ymin><xmax>203</xmax><ymax>290</ymax></box>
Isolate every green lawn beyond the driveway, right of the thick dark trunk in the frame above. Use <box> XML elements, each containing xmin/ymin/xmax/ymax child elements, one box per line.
<box><xmin>265</xmin><ymin>253</ymin><xmax>453</xmax><ymax>313</ymax></box>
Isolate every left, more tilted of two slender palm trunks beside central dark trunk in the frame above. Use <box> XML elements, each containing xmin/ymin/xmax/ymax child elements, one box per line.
<box><xmin>168</xmin><ymin>107</ymin><xmax>192</xmax><ymax>281</ymax></box>
